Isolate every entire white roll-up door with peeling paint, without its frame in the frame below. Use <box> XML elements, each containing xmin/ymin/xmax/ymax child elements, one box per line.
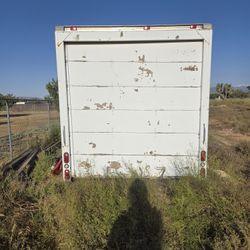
<box><xmin>66</xmin><ymin>41</ymin><xmax>203</xmax><ymax>176</ymax></box>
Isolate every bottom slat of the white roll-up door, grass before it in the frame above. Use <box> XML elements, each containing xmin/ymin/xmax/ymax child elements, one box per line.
<box><xmin>74</xmin><ymin>155</ymin><xmax>197</xmax><ymax>177</ymax></box>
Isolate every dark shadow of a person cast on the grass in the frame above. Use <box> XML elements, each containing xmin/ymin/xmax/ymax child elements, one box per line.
<box><xmin>107</xmin><ymin>179</ymin><xmax>163</xmax><ymax>250</ymax></box>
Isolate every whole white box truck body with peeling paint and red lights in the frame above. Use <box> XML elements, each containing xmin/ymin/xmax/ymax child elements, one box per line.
<box><xmin>56</xmin><ymin>24</ymin><xmax>212</xmax><ymax>179</ymax></box>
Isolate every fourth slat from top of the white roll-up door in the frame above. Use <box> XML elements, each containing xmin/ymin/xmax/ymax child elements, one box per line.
<box><xmin>71</xmin><ymin>110</ymin><xmax>199</xmax><ymax>134</ymax></box>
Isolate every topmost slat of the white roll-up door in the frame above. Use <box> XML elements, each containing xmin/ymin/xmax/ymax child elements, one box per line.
<box><xmin>67</xmin><ymin>41</ymin><xmax>202</xmax><ymax>62</ymax></box>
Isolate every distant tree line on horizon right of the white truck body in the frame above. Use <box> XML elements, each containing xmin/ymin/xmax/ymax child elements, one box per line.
<box><xmin>210</xmin><ymin>83</ymin><xmax>250</xmax><ymax>100</ymax></box>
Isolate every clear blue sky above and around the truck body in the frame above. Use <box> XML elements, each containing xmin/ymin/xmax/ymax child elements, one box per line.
<box><xmin>0</xmin><ymin>0</ymin><xmax>250</xmax><ymax>97</ymax></box>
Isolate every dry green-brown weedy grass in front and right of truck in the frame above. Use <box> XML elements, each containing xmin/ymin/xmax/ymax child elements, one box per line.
<box><xmin>0</xmin><ymin>100</ymin><xmax>250</xmax><ymax>250</ymax></box>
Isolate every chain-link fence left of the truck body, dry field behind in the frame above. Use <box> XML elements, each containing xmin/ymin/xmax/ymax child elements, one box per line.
<box><xmin>0</xmin><ymin>101</ymin><xmax>59</xmax><ymax>163</ymax></box>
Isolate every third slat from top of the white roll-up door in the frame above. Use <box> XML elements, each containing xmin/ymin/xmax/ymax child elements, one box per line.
<box><xmin>70</xmin><ymin>87</ymin><xmax>200</xmax><ymax>110</ymax></box>
